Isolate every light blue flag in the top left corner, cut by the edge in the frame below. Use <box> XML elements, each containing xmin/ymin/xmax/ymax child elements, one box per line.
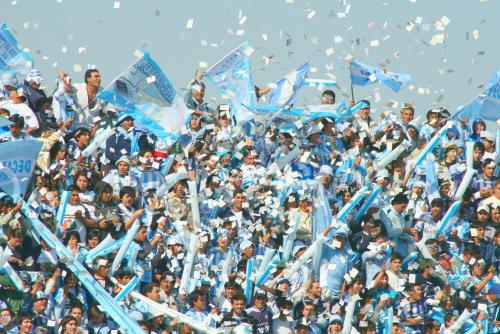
<box><xmin>0</xmin><ymin>23</ymin><xmax>33</xmax><ymax>75</ymax></box>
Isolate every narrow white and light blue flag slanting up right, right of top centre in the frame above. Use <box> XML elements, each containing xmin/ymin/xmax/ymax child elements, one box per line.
<box><xmin>269</xmin><ymin>63</ymin><xmax>311</xmax><ymax>108</ymax></box>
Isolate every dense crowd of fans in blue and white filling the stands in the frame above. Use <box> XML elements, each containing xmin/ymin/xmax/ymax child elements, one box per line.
<box><xmin>0</xmin><ymin>69</ymin><xmax>500</xmax><ymax>334</ymax></box>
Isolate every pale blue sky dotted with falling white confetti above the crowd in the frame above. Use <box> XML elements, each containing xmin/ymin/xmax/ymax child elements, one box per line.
<box><xmin>0</xmin><ymin>0</ymin><xmax>500</xmax><ymax>119</ymax></box>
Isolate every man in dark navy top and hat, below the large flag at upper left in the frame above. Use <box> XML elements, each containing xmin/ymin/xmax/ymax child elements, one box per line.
<box><xmin>105</xmin><ymin>114</ymin><xmax>134</xmax><ymax>166</ymax></box>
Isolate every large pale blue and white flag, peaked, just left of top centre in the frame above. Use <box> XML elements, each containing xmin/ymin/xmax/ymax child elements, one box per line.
<box><xmin>205</xmin><ymin>42</ymin><xmax>255</xmax><ymax>124</ymax></box>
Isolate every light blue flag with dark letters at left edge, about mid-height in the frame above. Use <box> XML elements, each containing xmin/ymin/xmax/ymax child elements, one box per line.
<box><xmin>0</xmin><ymin>140</ymin><xmax>42</xmax><ymax>195</ymax></box>
